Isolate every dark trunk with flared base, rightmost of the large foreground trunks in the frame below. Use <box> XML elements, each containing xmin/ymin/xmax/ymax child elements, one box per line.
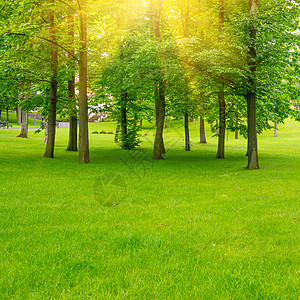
<box><xmin>245</xmin><ymin>0</ymin><xmax>259</xmax><ymax>170</ymax></box>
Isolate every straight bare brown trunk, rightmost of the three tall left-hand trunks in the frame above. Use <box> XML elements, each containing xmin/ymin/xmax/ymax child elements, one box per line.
<box><xmin>78</xmin><ymin>0</ymin><xmax>90</xmax><ymax>163</ymax></box>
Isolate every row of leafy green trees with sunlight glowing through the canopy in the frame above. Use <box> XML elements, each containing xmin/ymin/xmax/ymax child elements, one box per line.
<box><xmin>0</xmin><ymin>0</ymin><xmax>299</xmax><ymax>169</ymax></box>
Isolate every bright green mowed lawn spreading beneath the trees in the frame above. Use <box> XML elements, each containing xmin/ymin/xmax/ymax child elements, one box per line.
<box><xmin>0</xmin><ymin>120</ymin><xmax>300</xmax><ymax>299</ymax></box>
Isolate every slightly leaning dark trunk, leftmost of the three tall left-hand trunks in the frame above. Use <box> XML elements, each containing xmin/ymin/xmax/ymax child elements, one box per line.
<box><xmin>44</xmin><ymin>0</ymin><xmax>58</xmax><ymax>158</ymax></box>
